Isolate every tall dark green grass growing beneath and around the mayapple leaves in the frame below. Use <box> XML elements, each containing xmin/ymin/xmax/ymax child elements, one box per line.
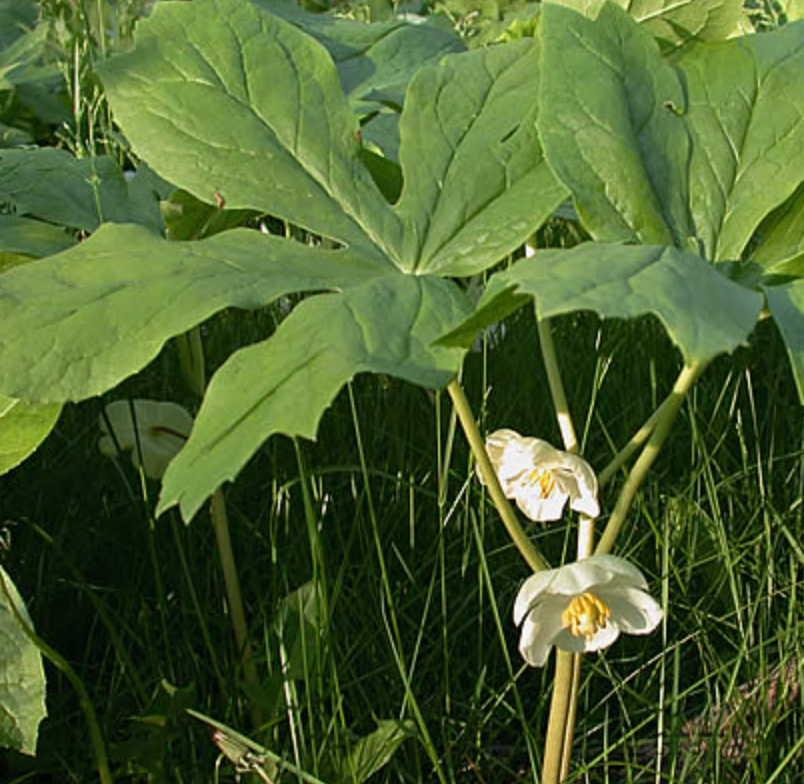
<box><xmin>0</xmin><ymin>2</ymin><xmax>804</xmax><ymax>784</ymax></box>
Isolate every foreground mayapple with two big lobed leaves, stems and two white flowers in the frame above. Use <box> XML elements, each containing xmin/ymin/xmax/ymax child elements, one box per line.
<box><xmin>0</xmin><ymin>0</ymin><xmax>804</xmax><ymax>784</ymax></box>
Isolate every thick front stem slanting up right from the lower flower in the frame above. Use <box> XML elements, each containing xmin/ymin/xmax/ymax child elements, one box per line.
<box><xmin>595</xmin><ymin>362</ymin><xmax>706</xmax><ymax>555</ymax></box>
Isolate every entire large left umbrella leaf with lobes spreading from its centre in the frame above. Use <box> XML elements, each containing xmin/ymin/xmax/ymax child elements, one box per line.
<box><xmin>0</xmin><ymin>0</ymin><xmax>566</xmax><ymax>518</ymax></box>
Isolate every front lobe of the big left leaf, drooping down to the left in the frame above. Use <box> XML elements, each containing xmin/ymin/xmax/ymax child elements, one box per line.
<box><xmin>158</xmin><ymin>273</ymin><xmax>470</xmax><ymax>520</ymax></box>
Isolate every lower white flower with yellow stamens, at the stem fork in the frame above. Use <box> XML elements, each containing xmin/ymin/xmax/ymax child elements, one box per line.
<box><xmin>514</xmin><ymin>555</ymin><xmax>662</xmax><ymax>667</ymax></box>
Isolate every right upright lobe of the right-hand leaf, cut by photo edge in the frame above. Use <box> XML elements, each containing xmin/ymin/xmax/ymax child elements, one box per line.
<box><xmin>679</xmin><ymin>23</ymin><xmax>804</xmax><ymax>261</ymax></box>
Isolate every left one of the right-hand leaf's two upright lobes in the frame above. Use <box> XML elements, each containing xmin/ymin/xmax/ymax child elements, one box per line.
<box><xmin>539</xmin><ymin>3</ymin><xmax>692</xmax><ymax>245</ymax></box>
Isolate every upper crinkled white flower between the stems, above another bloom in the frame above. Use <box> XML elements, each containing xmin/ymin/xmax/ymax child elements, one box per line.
<box><xmin>478</xmin><ymin>430</ymin><xmax>600</xmax><ymax>522</ymax></box>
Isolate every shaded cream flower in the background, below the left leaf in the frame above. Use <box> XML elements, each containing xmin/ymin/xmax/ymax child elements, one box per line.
<box><xmin>98</xmin><ymin>400</ymin><xmax>193</xmax><ymax>479</ymax></box>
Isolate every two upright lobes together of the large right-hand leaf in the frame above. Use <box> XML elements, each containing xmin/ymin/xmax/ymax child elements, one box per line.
<box><xmin>539</xmin><ymin>3</ymin><xmax>804</xmax><ymax>261</ymax></box>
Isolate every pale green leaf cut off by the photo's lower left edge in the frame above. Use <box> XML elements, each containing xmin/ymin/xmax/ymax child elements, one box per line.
<box><xmin>0</xmin><ymin>566</ymin><xmax>47</xmax><ymax>754</ymax></box>
